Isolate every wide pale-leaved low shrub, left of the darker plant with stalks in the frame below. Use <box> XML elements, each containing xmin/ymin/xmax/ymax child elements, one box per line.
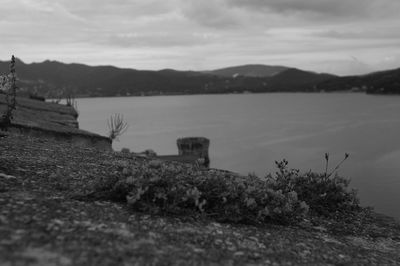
<box><xmin>97</xmin><ymin>160</ymin><xmax>308</xmax><ymax>224</ymax></box>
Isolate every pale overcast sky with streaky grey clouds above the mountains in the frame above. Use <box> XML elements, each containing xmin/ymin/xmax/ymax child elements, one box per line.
<box><xmin>0</xmin><ymin>0</ymin><xmax>400</xmax><ymax>75</ymax></box>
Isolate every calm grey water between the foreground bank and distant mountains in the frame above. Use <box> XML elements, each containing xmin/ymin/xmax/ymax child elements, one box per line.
<box><xmin>78</xmin><ymin>93</ymin><xmax>400</xmax><ymax>218</ymax></box>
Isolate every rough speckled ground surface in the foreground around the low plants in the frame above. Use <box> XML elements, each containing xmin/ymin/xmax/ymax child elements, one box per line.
<box><xmin>0</xmin><ymin>134</ymin><xmax>400</xmax><ymax>266</ymax></box>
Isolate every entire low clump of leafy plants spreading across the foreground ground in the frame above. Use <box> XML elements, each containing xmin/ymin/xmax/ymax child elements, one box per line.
<box><xmin>94</xmin><ymin>152</ymin><xmax>359</xmax><ymax>224</ymax></box>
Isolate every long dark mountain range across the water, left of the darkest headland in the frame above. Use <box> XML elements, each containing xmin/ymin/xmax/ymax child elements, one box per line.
<box><xmin>0</xmin><ymin>60</ymin><xmax>337</xmax><ymax>98</ymax></box>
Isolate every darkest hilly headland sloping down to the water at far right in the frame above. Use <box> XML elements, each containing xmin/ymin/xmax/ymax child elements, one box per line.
<box><xmin>318</xmin><ymin>68</ymin><xmax>400</xmax><ymax>94</ymax></box>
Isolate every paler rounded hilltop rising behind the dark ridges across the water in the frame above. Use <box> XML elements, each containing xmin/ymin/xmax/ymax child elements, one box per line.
<box><xmin>204</xmin><ymin>65</ymin><xmax>288</xmax><ymax>77</ymax></box>
